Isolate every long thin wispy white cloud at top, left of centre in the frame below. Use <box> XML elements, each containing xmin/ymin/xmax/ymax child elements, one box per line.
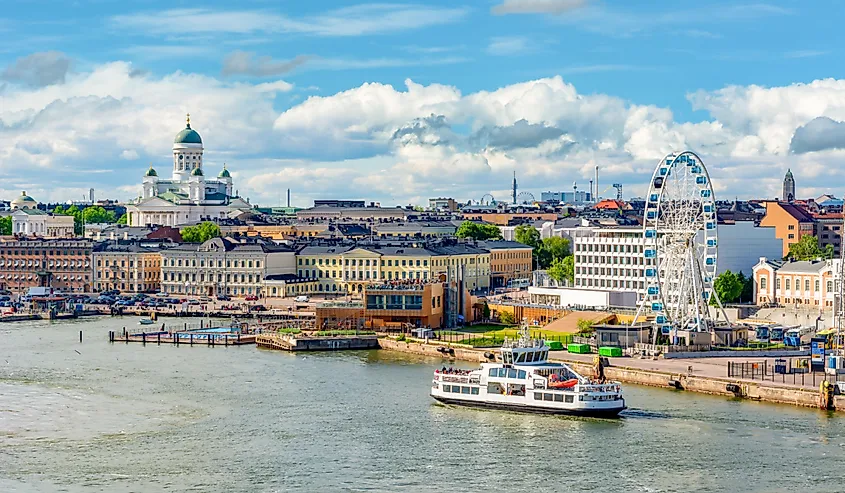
<box><xmin>111</xmin><ymin>3</ymin><xmax>469</xmax><ymax>36</ymax></box>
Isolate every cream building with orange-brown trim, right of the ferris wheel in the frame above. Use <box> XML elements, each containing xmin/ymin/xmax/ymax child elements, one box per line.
<box><xmin>753</xmin><ymin>257</ymin><xmax>839</xmax><ymax>310</ymax></box>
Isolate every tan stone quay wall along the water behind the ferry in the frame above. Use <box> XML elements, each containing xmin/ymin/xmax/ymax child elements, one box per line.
<box><xmin>379</xmin><ymin>337</ymin><xmax>845</xmax><ymax>412</ymax></box>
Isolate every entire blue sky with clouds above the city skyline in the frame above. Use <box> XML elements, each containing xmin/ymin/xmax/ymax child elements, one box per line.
<box><xmin>0</xmin><ymin>0</ymin><xmax>845</xmax><ymax>207</ymax></box>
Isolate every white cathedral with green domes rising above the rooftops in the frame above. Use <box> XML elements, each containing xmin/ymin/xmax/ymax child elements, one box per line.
<box><xmin>126</xmin><ymin>115</ymin><xmax>252</xmax><ymax>226</ymax></box>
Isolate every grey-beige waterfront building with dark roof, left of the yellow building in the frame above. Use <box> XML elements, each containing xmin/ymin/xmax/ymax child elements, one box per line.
<box><xmin>161</xmin><ymin>237</ymin><xmax>296</xmax><ymax>296</ymax></box>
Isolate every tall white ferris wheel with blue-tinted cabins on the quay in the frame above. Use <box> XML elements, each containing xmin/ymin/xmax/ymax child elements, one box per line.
<box><xmin>634</xmin><ymin>151</ymin><xmax>727</xmax><ymax>335</ymax></box>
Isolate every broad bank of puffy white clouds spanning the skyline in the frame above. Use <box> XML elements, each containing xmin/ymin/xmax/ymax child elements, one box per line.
<box><xmin>8</xmin><ymin>55</ymin><xmax>845</xmax><ymax>205</ymax></box>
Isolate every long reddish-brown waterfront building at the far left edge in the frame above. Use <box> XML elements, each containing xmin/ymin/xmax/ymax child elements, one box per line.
<box><xmin>0</xmin><ymin>236</ymin><xmax>93</xmax><ymax>293</ymax></box>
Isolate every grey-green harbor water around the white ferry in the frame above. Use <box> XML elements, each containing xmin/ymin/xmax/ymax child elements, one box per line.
<box><xmin>0</xmin><ymin>317</ymin><xmax>845</xmax><ymax>492</ymax></box>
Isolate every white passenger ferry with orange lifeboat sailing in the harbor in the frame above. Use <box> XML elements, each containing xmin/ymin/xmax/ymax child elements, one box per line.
<box><xmin>431</xmin><ymin>327</ymin><xmax>625</xmax><ymax>417</ymax></box>
